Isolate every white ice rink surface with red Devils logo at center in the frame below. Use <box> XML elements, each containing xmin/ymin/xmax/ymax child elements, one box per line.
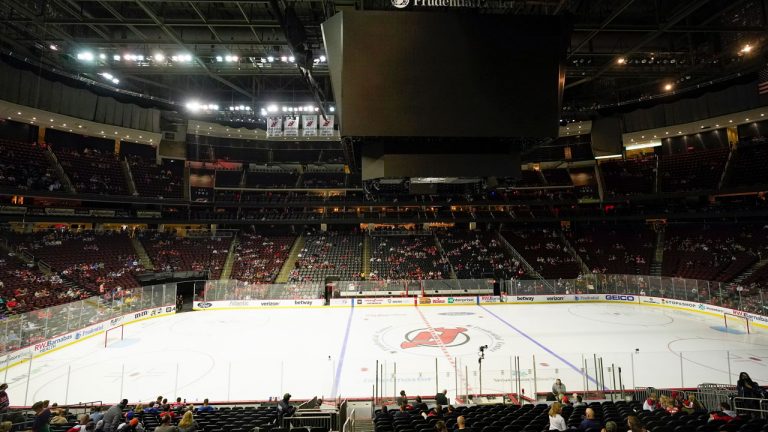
<box><xmin>3</xmin><ymin>303</ymin><xmax>768</xmax><ymax>405</ymax></box>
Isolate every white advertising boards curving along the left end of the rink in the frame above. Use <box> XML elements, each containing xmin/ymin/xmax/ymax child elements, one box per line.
<box><xmin>0</xmin><ymin>305</ymin><xmax>176</xmax><ymax>367</ymax></box>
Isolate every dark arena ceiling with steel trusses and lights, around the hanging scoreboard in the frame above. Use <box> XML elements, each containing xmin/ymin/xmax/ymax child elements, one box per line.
<box><xmin>0</xmin><ymin>0</ymin><xmax>768</xmax><ymax>118</ymax></box>
